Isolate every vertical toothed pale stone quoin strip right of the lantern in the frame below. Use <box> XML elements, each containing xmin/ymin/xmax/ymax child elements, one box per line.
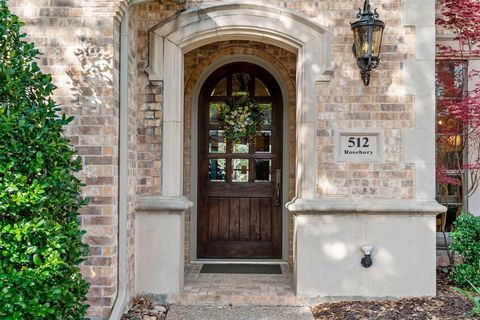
<box><xmin>403</xmin><ymin>0</ymin><xmax>435</xmax><ymax>199</ymax></box>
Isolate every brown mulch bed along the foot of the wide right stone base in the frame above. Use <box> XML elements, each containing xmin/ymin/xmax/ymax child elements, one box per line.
<box><xmin>312</xmin><ymin>270</ymin><xmax>480</xmax><ymax>320</ymax></box>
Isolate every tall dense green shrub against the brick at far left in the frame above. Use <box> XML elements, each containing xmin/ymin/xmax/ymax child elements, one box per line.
<box><xmin>0</xmin><ymin>0</ymin><xmax>88</xmax><ymax>320</ymax></box>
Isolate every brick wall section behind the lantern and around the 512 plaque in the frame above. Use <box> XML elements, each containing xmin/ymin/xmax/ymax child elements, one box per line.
<box><xmin>316</xmin><ymin>0</ymin><xmax>414</xmax><ymax>199</ymax></box>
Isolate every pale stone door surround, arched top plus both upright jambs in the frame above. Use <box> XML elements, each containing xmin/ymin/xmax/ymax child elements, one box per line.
<box><xmin>146</xmin><ymin>2</ymin><xmax>332</xmax><ymax>198</ymax></box>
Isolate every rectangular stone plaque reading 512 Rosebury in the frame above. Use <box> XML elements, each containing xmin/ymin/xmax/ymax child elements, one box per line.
<box><xmin>335</xmin><ymin>129</ymin><xmax>383</xmax><ymax>162</ymax></box>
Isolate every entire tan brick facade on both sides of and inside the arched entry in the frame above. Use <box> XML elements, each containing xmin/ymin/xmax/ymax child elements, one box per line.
<box><xmin>9</xmin><ymin>0</ymin><xmax>422</xmax><ymax>318</ymax></box>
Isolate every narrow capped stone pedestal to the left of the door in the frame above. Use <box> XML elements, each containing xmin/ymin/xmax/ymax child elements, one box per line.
<box><xmin>135</xmin><ymin>197</ymin><xmax>193</xmax><ymax>294</ymax></box>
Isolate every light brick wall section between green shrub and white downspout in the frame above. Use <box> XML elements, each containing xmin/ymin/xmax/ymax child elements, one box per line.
<box><xmin>8</xmin><ymin>0</ymin><xmax>125</xmax><ymax>318</ymax></box>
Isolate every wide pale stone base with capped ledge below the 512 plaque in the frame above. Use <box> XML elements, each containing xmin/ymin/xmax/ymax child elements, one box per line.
<box><xmin>288</xmin><ymin>198</ymin><xmax>445</xmax><ymax>299</ymax></box>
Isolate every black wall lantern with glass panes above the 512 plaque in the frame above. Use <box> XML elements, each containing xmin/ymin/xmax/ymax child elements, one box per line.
<box><xmin>350</xmin><ymin>0</ymin><xmax>385</xmax><ymax>86</ymax></box>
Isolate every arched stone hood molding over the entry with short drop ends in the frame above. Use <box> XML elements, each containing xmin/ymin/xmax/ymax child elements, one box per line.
<box><xmin>146</xmin><ymin>1</ymin><xmax>332</xmax><ymax>81</ymax></box>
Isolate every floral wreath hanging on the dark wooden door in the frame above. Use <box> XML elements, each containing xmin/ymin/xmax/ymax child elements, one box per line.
<box><xmin>218</xmin><ymin>96</ymin><xmax>263</xmax><ymax>143</ymax></box>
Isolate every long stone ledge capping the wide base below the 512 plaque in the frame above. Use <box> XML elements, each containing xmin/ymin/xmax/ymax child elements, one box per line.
<box><xmin>286</xmin><ymin>198</ymin><xmax>447</xmax><ymax>215</ymax></box>
